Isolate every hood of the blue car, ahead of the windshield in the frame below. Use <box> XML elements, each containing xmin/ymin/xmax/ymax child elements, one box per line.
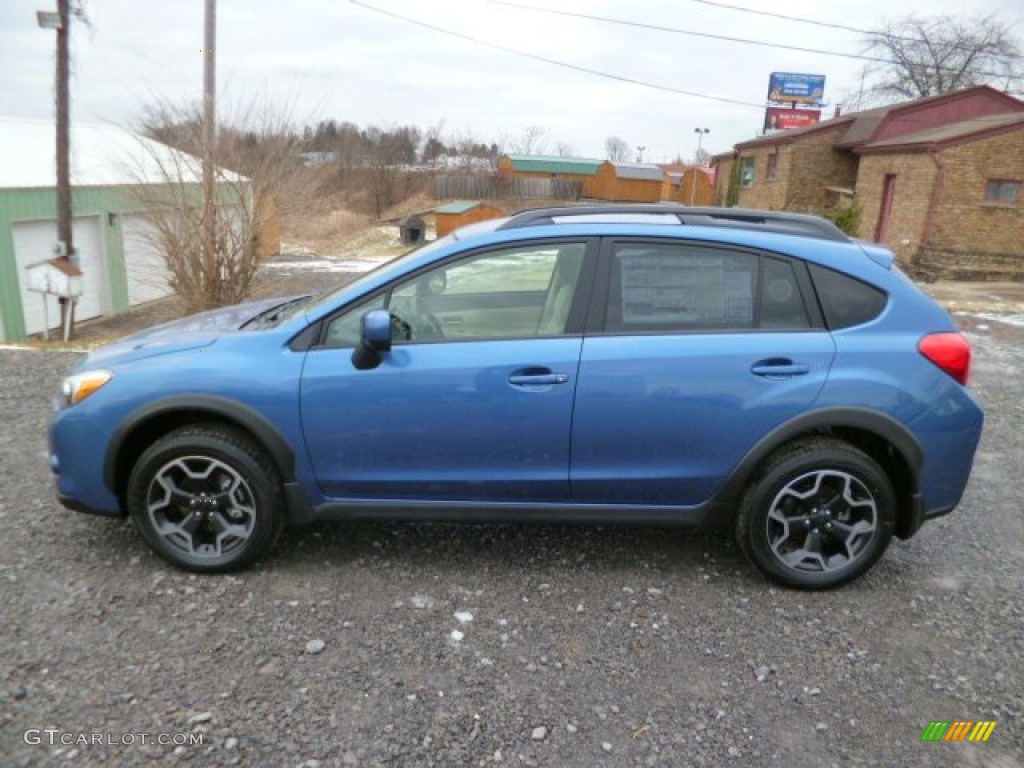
<box><xmin>77</xmin><ymin>296</ymin><xmax>302</xmax><ymax>369</ymax></box>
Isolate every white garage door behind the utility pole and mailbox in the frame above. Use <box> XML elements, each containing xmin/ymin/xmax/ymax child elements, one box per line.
<box><xmin>14</xmin><ymin>216</ymin><xmax>110</xmax><ymax>334</ymax></box>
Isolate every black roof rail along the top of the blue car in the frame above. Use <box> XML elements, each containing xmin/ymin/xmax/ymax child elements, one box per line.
<box><xmin>498</xmin><ymin>203</ymin><xmax>850</xmax><ymax>242</ymax></box>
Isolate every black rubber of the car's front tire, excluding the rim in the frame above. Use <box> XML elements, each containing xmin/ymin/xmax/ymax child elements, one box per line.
<box><xmin>126</xmin><ymin>432</ymin><xmax>281</xmax><ymax>573</ymax></box>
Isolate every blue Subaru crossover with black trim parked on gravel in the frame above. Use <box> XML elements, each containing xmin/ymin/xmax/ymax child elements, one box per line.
<box><xmin>50</xmin><ymin>205</ymin><xmax>983</xmax><ymax>589</ymax></box>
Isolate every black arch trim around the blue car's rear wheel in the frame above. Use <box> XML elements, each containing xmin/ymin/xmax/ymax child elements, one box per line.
<box><xmin>715</xmin><ymin>408</ymin><xmax>925</xmax><ymax>512</ymax></box>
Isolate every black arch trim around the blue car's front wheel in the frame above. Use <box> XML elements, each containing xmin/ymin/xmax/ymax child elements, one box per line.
<box><xmin>103</xmin><ymin>394</ymin><xmax>295</xmax><ymax>496</ymax></box>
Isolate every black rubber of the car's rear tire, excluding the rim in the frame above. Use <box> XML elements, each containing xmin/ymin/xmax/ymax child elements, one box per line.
<box><xmin>740</xmin><ymin>445</ymin><xmax>896</xmax><ymax>589</ymax></box>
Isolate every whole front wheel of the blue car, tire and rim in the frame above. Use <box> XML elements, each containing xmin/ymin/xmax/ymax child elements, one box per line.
<box><xmin>126</xmin><ymin>424</ymin><xmax>286</xmax><ymax>573</ymax></box>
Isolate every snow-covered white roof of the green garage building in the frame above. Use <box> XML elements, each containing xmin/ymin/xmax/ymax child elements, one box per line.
<box><xmin>0</xmin><ymin>117</ymin><xmax>240</xmax><ymax>188</ymax></box>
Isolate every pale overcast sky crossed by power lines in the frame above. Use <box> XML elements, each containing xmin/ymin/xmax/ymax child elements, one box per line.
<box><xmin>0</xmin><ymin>0</ymin><xmax>1024</xmax><ymax>163</ymax></box>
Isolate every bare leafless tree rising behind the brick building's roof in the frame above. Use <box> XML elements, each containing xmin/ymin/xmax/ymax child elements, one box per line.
<box><xmin>859</xmin><ymin>15</ymin><xmax>1024</xmax><ymax>103</ymax></box>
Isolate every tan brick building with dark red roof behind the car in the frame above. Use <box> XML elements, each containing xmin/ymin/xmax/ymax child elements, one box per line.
<box><xmin>715</xmin><ymin>86</ymin><xmax>1024</xmax><ymax>280</ymax></box>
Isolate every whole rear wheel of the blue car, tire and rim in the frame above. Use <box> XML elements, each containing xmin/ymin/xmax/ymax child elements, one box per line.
<box><xmin>736</xmin><ymin>438</ymin><xmax>896</xmax><ymax>590</ymax></box>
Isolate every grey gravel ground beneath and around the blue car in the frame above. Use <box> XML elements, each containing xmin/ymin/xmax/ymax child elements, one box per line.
<box><xmin>0</xmin><ymin>296</ymin><xmax>1024</xmax><ymax>768</ymax></box>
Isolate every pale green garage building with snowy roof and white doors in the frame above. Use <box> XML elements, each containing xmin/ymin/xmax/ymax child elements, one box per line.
<box><xmin>0</xmin><ymin>117</ymin><xmax>222</xmax><ymax>341</ymax></box>
